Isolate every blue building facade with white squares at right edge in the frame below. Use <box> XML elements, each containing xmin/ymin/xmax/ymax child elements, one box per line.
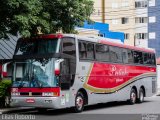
<box><xmin>148</xmin><ymin>0</ymin><xmax>160</xmax><ymax>59</ymax></box>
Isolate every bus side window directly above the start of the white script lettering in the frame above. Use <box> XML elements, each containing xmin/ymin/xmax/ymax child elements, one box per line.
<box><xmin>109</xmin><ymin>46</ymin><xmax>122</xmax><ymax>62</ymax></box>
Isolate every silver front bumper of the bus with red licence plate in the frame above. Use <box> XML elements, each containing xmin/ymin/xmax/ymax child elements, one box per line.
<box><xmin>11</xmin><ymin>97</ymin><xmax>61</xmax><ymax>109</ymax></box>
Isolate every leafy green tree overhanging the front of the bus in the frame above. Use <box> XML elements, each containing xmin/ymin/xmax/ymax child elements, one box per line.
<box><xmin>0</xmin><ymin>0</ymin><xmax>93</xmax><ymax>38</ymax></box>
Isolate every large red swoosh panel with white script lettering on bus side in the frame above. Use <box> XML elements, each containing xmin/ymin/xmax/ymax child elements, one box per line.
<box><xmin>87</xmin><ymin>63</ymin><xmax>156</xmax><ymax>89</ymax></box>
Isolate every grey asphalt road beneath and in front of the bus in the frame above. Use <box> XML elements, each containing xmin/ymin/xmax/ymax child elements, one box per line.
<box><xmin>0</xmin><ymin>96</ymin><xmax>160</xmax><ymax>120</ymax></box>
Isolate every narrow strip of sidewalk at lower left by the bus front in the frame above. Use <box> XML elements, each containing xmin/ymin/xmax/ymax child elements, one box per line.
<box><xmin>0</xmin><ymin>107</ymin><xmax>35</xmax><ymax>115</ymax></box>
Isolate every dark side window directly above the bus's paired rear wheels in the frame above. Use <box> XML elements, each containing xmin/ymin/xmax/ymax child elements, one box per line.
<box><xmin>134</xmin><ymin>51</ymin><xmax>143</xmax><ymax>64</ymax></box>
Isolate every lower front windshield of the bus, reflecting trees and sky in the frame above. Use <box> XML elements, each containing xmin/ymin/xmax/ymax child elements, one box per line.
<box><xmin>13</xmin><ymin>58</ymin><xmax>58</xmax><ymax>87</ymax></box>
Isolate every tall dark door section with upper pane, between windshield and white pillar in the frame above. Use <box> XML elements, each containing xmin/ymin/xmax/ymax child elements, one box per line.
<box><xmin>60</xmin><ymin>37</ymin><xmax>76</xmax><ymax>90</ymax></box>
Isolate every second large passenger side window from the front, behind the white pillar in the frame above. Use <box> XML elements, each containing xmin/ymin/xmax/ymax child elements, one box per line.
<box><xmin>96</xmin><ymin>44</ymin><xmax>110</xmax><ymax>61</ymax></box>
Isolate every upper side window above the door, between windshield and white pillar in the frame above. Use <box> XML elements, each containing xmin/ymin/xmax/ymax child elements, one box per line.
<box><xmin>62</xmin><ymin>38</ymin><xmax>76</xmax><ymax>57</ymax></box>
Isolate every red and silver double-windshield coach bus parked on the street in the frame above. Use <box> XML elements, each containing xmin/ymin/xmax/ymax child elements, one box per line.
<box><xmin>11</xmin><ymin>34</ymin><xmax>157</xmax><ymax>112</ymax></box>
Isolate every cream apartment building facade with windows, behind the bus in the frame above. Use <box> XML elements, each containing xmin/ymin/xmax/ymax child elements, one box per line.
<box><xmin>91</xmin><ymin>0</ymin><xmax>148</xmax><ymax>47</ymax></box>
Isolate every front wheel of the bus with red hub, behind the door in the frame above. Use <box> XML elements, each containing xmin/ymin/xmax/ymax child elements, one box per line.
<box><xmin>74</xmin><ymin>92</ymin><xmax>85</xmax><ymax>113</ymax></box>
